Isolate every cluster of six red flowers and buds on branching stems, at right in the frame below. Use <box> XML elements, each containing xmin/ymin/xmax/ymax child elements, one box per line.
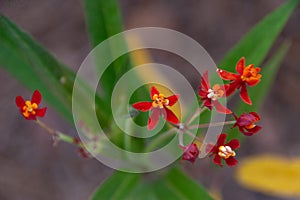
<box><xmin>132</xmin><ymin>58</ymin><xmax>262</xmax><ymax>166</ymax></box>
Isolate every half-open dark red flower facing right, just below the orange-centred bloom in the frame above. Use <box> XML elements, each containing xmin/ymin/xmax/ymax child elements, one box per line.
<box><xmin>233</xmin><ymin>112</ymin><xmax>261</xmax><ymax>136</ymax></box>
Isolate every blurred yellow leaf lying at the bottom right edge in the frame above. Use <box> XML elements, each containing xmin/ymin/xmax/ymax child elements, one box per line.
<box><xmin>236</xmin><ymin>155</ymin><xmax>300</xmax><ymax>197</ymax></box>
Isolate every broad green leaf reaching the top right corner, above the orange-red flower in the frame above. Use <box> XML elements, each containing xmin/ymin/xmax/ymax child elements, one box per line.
<box><xmin>219</xmin><ymin>0</ymin><xmax>299</xmax><ymax>71</ymax></box>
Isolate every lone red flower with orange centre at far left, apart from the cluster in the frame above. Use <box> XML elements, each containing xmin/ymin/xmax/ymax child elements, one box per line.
<box><xmin>16</xmin><ymin>90</ymin><xmax>47</xmax><ymax>120</ymax></box>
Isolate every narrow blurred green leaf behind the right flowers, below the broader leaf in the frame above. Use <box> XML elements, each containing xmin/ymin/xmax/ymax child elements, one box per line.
<box><xmin>228</xmin><ymin>42</ymin><xmax>290</xmax><ymax>139</ymax></box>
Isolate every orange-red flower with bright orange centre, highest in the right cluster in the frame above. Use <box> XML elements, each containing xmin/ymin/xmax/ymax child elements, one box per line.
<box><xmin>217</xmin><ymin>57</ymin><xmax>262</xmax><ymax>105</ymax></box>
